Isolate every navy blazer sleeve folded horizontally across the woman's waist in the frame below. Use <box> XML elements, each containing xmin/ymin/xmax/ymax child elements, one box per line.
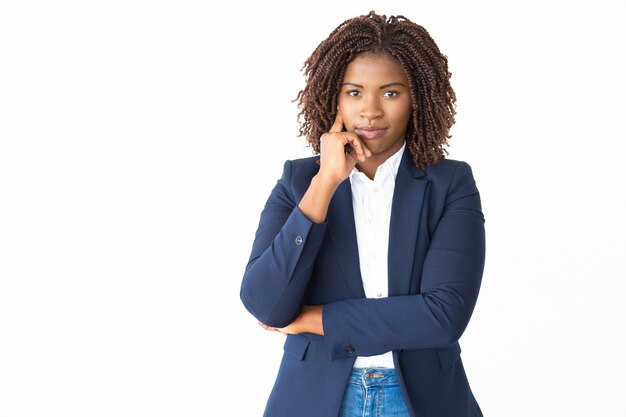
<box><xmin>322</xmin><ymin>162</ymin><xmax>485</xmax><ymax>359</ymax></box>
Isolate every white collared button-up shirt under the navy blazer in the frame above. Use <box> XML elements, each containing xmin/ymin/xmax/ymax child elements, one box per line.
<box><xmin>350</xmin><ymin>142</ymin><xmax>406</xmax><ymax>368</ymax></box>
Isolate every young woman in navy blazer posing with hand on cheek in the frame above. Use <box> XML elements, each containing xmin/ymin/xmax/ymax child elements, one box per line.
<box><xmin>241</xmin><ymin>12</ymin><xmax>485</xmax><ymax>417</ymax></box>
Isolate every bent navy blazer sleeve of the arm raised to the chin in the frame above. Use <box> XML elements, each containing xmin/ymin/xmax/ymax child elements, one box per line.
<box><xmin>240</xmin><ymin>161</ymin><xmax>326</xmax><ymax>327</ymax></box>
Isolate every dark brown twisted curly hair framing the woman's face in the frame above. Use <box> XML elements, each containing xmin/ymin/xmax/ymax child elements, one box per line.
<box><xmin>294</xmin><ymin>11</ymin><xmax>456</xmax><ymax>169</ymax></box>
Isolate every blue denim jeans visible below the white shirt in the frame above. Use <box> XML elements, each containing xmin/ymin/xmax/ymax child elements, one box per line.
<box><xmin>339</xmin><ymin>368</ymin><xmax>410</xmax><ymax>417</ymax></box>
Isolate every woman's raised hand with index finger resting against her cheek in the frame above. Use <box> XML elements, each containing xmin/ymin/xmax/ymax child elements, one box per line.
<box><xmin>318</xmin><ymin>111</ymin><xmax>372</xmax><ymax>184</ymax></box>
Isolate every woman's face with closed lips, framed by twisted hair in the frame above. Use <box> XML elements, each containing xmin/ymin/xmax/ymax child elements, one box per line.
<box><xmin>339</xmin><ymin>53</ymin><xmax>412</xmax><ymax>159</ymax></box>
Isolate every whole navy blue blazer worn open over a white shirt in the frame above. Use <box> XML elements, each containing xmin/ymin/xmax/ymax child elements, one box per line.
<box><xmin>241</xmin><ymin>147</ymin><xmax>485</xmax><ymax>417</ymax></box>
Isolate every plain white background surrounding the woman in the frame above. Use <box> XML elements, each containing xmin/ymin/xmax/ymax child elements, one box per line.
<box><xmin>0</xmin><ymin>0</ymin><xmax>626</xmax><ymax>417</ymax></box>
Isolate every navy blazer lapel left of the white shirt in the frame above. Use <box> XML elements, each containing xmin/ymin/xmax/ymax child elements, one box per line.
<box><xmin>327</xmin><ymin>179</ymin><xmax>365</xmax><ymax>297</ymax></box>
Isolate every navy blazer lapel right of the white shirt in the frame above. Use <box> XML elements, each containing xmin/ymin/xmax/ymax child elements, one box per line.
<box><xmin>388</xmin><ymin>150</ymin><xmax>428</xmax><ymax>297</ymax></box>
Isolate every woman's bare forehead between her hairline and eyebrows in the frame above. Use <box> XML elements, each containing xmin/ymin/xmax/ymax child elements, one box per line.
<box><xmin>343</xmin><ymin>54</ymin><xmax>407</xmax><ymax>85</ymax></box>
